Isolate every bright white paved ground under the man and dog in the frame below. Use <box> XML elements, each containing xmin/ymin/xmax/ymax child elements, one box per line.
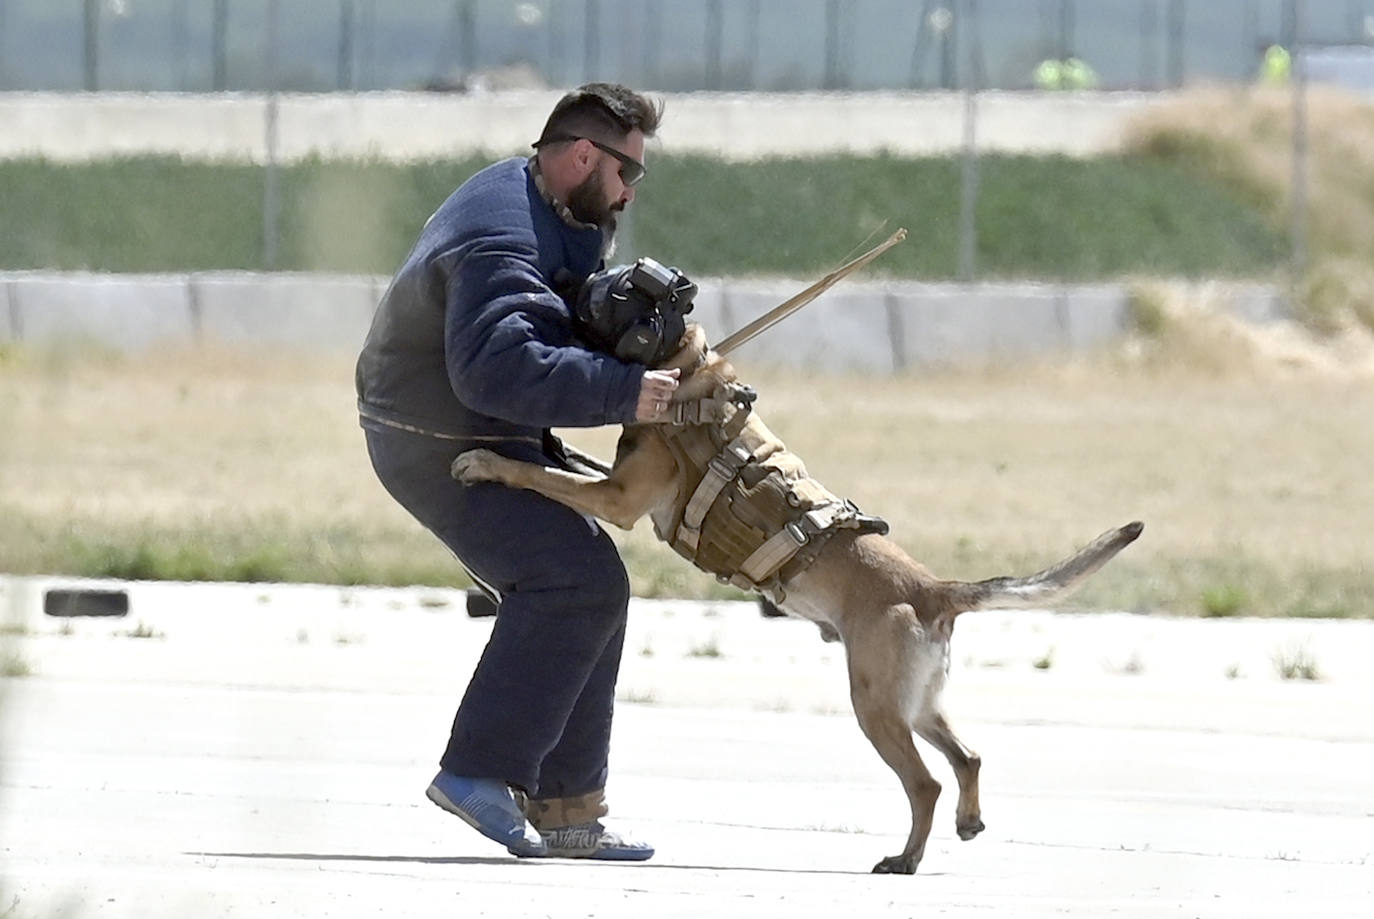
<box><xmin>0</xmin><ymin>578</ymin><xmax>1374</xmax><ymax>919</ymax></box>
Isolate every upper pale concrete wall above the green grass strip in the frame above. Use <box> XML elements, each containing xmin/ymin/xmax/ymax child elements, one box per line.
<box><xmin>0</xmin><ymin>91</ymin><xmax>1169</xmax><ymax>162</ymax></box>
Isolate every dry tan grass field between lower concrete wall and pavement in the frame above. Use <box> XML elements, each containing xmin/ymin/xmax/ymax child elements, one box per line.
<box><xmin>0</xmin><ymin>304</ymin><xmax>1374</xmax><ymax>615</ymax></box>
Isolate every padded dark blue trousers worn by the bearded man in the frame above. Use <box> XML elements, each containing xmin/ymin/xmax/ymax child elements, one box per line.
<box><xmin>365</xmin><ymin>430</ymin><xmax>629</xmax><ymax>798</ymax></box>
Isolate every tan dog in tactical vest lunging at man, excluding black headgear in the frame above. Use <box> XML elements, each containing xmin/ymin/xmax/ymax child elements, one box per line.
<box><xmin>452</xmin><ymin>252</ymin><xmax>1143</xmax><ymax>874</ymax></box>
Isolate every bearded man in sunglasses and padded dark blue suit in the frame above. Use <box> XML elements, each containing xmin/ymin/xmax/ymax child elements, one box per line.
<box><xmin>356</xmin><ymin>84</ymin><xmax>677</xmax><ymax>860</ymax></box>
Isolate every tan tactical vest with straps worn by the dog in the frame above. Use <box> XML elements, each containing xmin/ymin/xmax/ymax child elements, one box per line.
<box><xmin>655</xmin><ymin>383</ymin><xmax>888</xmax><ymax>603</ymax></box>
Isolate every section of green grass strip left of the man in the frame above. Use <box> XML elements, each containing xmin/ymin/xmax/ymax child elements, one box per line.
<box><xmin>0</xmin><ymin>157</ymin><xmax>486</xmax><ymax>272</ymax></box>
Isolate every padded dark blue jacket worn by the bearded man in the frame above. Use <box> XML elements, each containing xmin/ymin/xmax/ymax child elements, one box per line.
<box><xmin>354</xmin><ymin>158</ymin><xmax>644</xmax><ymax>449</ymax></box>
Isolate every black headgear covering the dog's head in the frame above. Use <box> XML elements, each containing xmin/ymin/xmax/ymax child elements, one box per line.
<box><xmin>573</xmin><ymin>258</ymin><xmax>697</xmax><ymax>367</ymax></box>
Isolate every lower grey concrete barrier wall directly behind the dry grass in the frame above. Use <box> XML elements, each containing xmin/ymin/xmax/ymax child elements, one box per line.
<box><xmin>0</xmin><ymin>272</ymin><xmax>1285</xmax><ymax>374</ymax></box>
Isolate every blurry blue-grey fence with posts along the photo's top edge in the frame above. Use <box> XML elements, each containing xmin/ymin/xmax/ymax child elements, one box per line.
<box><xmin>0</xmin><ymin>0</ymin><xmax>1374</xmax><ymax>92</ymax></box>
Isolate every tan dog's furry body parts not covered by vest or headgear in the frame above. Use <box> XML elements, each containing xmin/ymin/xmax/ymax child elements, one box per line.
<box><xmin>453</xmin><ymin>326</ymin><xmax>1143</xmax><ymax>874</ymax></box>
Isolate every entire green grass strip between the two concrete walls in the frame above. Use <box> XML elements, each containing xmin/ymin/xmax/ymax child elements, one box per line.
<box><xmin>0</xmin><ymin>155</ymin><xmax>1285</xmax><ymax>280</ymax></box>
